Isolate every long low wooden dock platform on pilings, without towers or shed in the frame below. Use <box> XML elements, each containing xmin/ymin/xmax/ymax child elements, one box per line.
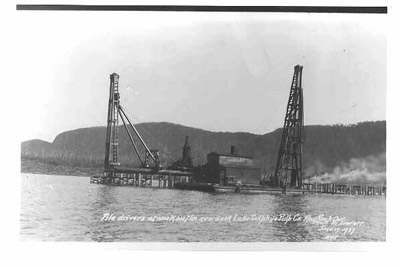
<box><xmin>90</xmin><ymin>173</ymin><xmax>386</xmax><ymax>196</ymax></box>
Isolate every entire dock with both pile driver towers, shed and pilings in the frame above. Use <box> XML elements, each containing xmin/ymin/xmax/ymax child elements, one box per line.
<box><xmin>90</xmin><ymin>68</ymin><xmax>386</xmax><ymax>196</ymax></box>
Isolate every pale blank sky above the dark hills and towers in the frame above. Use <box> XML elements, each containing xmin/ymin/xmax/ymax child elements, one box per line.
<box><xmin>16</xmin><ymin>12</ymin><xmax>386</xmax><ymax>141</ymax></box>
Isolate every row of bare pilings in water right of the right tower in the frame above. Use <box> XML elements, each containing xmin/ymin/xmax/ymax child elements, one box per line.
<box><xmin>301</xmin><ymin>182</ymin><xmax>386</xmax><ymax>196</ymax></box>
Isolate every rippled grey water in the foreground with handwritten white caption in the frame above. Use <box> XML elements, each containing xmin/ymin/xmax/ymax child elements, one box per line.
<box><xmin>21</xmin><ymin>174</ymin><xmax>386</xmax><ymax>242</ymax></box>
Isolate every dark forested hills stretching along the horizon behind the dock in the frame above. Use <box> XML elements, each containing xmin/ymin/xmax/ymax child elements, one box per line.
<box><xmin>21</xmin><ymin>121</ymin><xmax>386</xmax><ymax>176</ymax></box>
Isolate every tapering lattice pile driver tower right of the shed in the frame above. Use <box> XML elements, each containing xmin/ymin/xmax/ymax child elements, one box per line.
<box><xmin>273</xmin><ymin>65</ymin><xmax>304</xmax><ymax>188</ymax></box>
